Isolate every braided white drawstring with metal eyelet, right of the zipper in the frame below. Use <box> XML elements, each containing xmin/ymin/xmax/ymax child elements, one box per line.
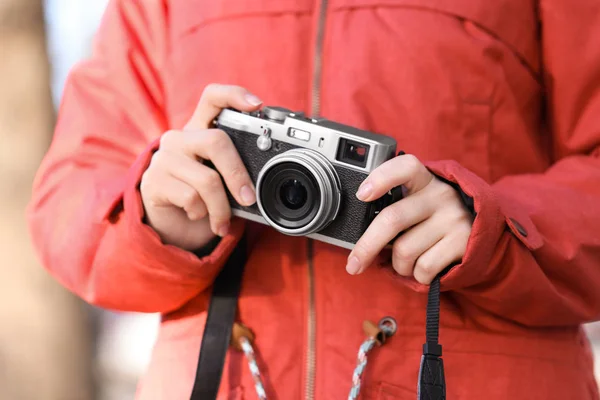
<box><xmin>348</xmin><ymin>317</ymin><xmax>398</xmax><ymax>400</ymax></box>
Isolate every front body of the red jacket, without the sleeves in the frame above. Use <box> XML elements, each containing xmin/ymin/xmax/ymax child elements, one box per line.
<box><xmin>139</xmin><ymin>0</ymin><xmax>595</xmax><ymax>399</ymax></box>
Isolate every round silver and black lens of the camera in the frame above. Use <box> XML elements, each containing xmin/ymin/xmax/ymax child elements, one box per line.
<box><xmin>256</xmin><ymin>149</ymin><xmax>341</xmax><ymax>235</ymax></box>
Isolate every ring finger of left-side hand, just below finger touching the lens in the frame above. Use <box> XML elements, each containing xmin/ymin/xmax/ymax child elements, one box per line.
<box><xmin>153</xmin><ymin>152</ymin><xmax>231</xmax><ymax>236</ymax></box>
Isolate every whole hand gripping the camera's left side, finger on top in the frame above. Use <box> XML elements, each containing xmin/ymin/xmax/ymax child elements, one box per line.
<box><xmin>140</xmin><ymin>84</ymin><xmax>262</xmax><ymax>250</ymax></box>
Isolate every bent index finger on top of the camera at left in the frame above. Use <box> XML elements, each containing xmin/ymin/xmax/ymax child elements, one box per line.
<box><xmin>184</xmin><ymin>83</ymin><xmax>262</xmax><ymax>130</ymax></box>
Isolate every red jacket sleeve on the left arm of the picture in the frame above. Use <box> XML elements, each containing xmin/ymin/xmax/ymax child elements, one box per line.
<box><xmin>28</xmin><ymin>0</ymin><xmax>243</xmax><ymax>312</ymax></box>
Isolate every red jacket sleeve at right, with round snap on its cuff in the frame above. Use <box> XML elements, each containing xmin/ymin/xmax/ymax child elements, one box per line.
<box><xmin>411</xmin><ymin>0</ymin><xmax>600</xmax><ymax>326</ymax></box>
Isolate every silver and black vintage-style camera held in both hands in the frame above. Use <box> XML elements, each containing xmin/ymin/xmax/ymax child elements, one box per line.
<box><xmin>215</xmin><ymin>107</ymin><xmax>402</xmax><ymax>249</ymax></box>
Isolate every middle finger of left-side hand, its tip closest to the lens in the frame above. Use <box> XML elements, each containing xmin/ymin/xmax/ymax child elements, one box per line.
<box><xmin>184</xmin><ymin>129</ymin><xmax>256</xmax><ymax>206</ymax></box>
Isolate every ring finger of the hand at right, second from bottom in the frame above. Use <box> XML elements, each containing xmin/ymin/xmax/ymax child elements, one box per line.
<box><xmin>392</xmin><ymin>214</ymin><xmax>450</xmax><ymax>276</ymax></box>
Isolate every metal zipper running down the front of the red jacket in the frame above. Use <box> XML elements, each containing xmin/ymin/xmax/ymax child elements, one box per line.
<box><xmin>304</xmin><ymin>0</ymin><xmax>328</xmax><ymax>400</ymax></box>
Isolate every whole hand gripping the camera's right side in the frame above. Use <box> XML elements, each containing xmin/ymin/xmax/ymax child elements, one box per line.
<box><xmin>346</xmin><ymin>154</ymin><xmax>473</xmax><ymax>285</ymax></box>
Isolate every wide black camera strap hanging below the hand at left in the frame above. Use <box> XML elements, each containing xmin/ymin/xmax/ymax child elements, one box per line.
<box><xmin>190</xmin><ymin>235</ymin><xmax>247</xmax><ymax>400</ymax></box>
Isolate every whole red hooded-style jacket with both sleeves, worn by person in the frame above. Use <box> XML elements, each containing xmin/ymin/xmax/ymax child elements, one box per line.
<box><xmin>29</xmin><ymin>0</ymin><xmax>600</xmax><ymax>400</ymax></box>
